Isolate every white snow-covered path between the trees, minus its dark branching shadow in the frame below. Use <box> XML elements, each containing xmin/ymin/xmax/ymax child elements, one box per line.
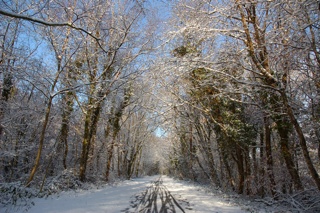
<box><xmin>0</xmin><ymin>176</ymin><xmax>278</xmax><ymax>213</ymax></box>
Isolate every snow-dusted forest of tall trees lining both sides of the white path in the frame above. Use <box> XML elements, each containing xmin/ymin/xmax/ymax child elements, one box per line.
<box><xmin>0</xmin><ymin>0</ymin><xmax>320</xmax><ymax>210</ymax></box>
